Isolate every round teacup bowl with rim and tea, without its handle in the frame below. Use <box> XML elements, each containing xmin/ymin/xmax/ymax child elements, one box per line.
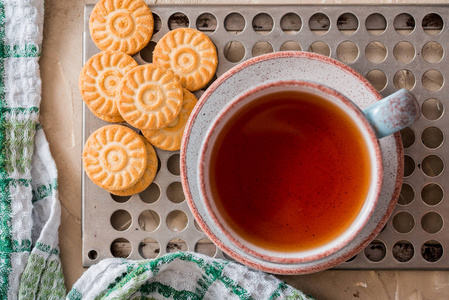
<box><xmin>199</xmin><ymin>80</ymin><xmax>382</xmax><ymax>263</ymax></box>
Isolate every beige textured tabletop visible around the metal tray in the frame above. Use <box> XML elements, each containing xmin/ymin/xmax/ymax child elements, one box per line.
<box><xmin>40</xmin><ymin>0</ymin><xmax>449</xmax><ymax>300</ymax></box>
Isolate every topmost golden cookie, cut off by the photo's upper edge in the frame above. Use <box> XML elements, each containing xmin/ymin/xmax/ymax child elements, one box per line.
<box><xmin>89</xmin><ymin>0</ymin><xmax>154</xmax><ymax>55</ymax></box>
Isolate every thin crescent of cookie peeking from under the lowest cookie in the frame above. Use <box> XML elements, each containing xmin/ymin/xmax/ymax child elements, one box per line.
<box><xmin>108</xmin><ymin>138</ymin><xmax>158</xmax><ymax>196</ymax></box>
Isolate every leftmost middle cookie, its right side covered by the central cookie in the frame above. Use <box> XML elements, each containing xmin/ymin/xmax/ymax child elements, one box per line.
<box><xmin>78</xmin><ymin>50</ymin><xmax>138</xmax><ymax>119</ymax></box>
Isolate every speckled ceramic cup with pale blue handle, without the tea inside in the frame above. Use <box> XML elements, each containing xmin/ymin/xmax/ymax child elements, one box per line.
<box><xmin>198</xmin><ymin>80</ymin><xmax>420</xmax><ymax>263</ymax></box>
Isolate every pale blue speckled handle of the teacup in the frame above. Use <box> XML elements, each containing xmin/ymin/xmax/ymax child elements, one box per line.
<box><xmin>363</xmin><ymin>89</ymin><xmax>420</xmax><ymax>139</ymax></box>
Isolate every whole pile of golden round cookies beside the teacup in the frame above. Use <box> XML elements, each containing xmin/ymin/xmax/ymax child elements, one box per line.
<box><xmin>79</xmin><ymin>0</ymin><xmax>218</xmax><ymax>196</ymax></box>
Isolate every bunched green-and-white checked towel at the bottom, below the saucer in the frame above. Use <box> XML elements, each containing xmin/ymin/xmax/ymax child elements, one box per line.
<box><xmin>67</xmin><ymin>252</ymin><xmax>314</xmax><ymax>300</ymax></box>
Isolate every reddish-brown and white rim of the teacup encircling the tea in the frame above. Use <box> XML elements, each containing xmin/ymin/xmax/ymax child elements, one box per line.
<box><xmin>198</xmin><ymin>79</ymin><xmax>383</xmax><ymax>264</ymax></box>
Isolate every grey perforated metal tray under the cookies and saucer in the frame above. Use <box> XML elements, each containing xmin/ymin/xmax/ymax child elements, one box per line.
<box><xmin>82</xmin><ymin>5</ymin><xmax>449</xmax><ymax>269</ymax></box>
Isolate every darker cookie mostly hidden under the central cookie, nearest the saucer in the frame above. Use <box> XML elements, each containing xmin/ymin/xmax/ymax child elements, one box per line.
<box><xmin>142</xmin><ymin>89</ymin><xmax>198</xmax><ymax>151</ymax></box>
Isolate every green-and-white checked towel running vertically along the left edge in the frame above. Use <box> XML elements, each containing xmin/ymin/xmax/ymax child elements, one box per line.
<box><xmin>0</xmin><ymin>0</ymin><xmax>65</xmax><ymax>299</ymax></box>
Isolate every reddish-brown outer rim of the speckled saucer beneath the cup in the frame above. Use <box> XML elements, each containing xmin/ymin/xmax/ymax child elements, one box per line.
<box><xmin>180</xmin><ymin>51</ymin><xmax>404</xmax><ymax>275</ymax></box>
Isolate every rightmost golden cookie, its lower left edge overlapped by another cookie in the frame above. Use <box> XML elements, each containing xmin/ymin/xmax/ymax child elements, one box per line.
<box><xmin>153</xmin><ymin>28</ymin><xmax>218</xmax><ymax>92</ymax></box>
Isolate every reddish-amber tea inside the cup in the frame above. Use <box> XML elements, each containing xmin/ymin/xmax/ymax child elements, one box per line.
<box><xmin>209</xmin><ymin>91</ymin><xmax>372</xmax><ymax>252</ymax></box>
